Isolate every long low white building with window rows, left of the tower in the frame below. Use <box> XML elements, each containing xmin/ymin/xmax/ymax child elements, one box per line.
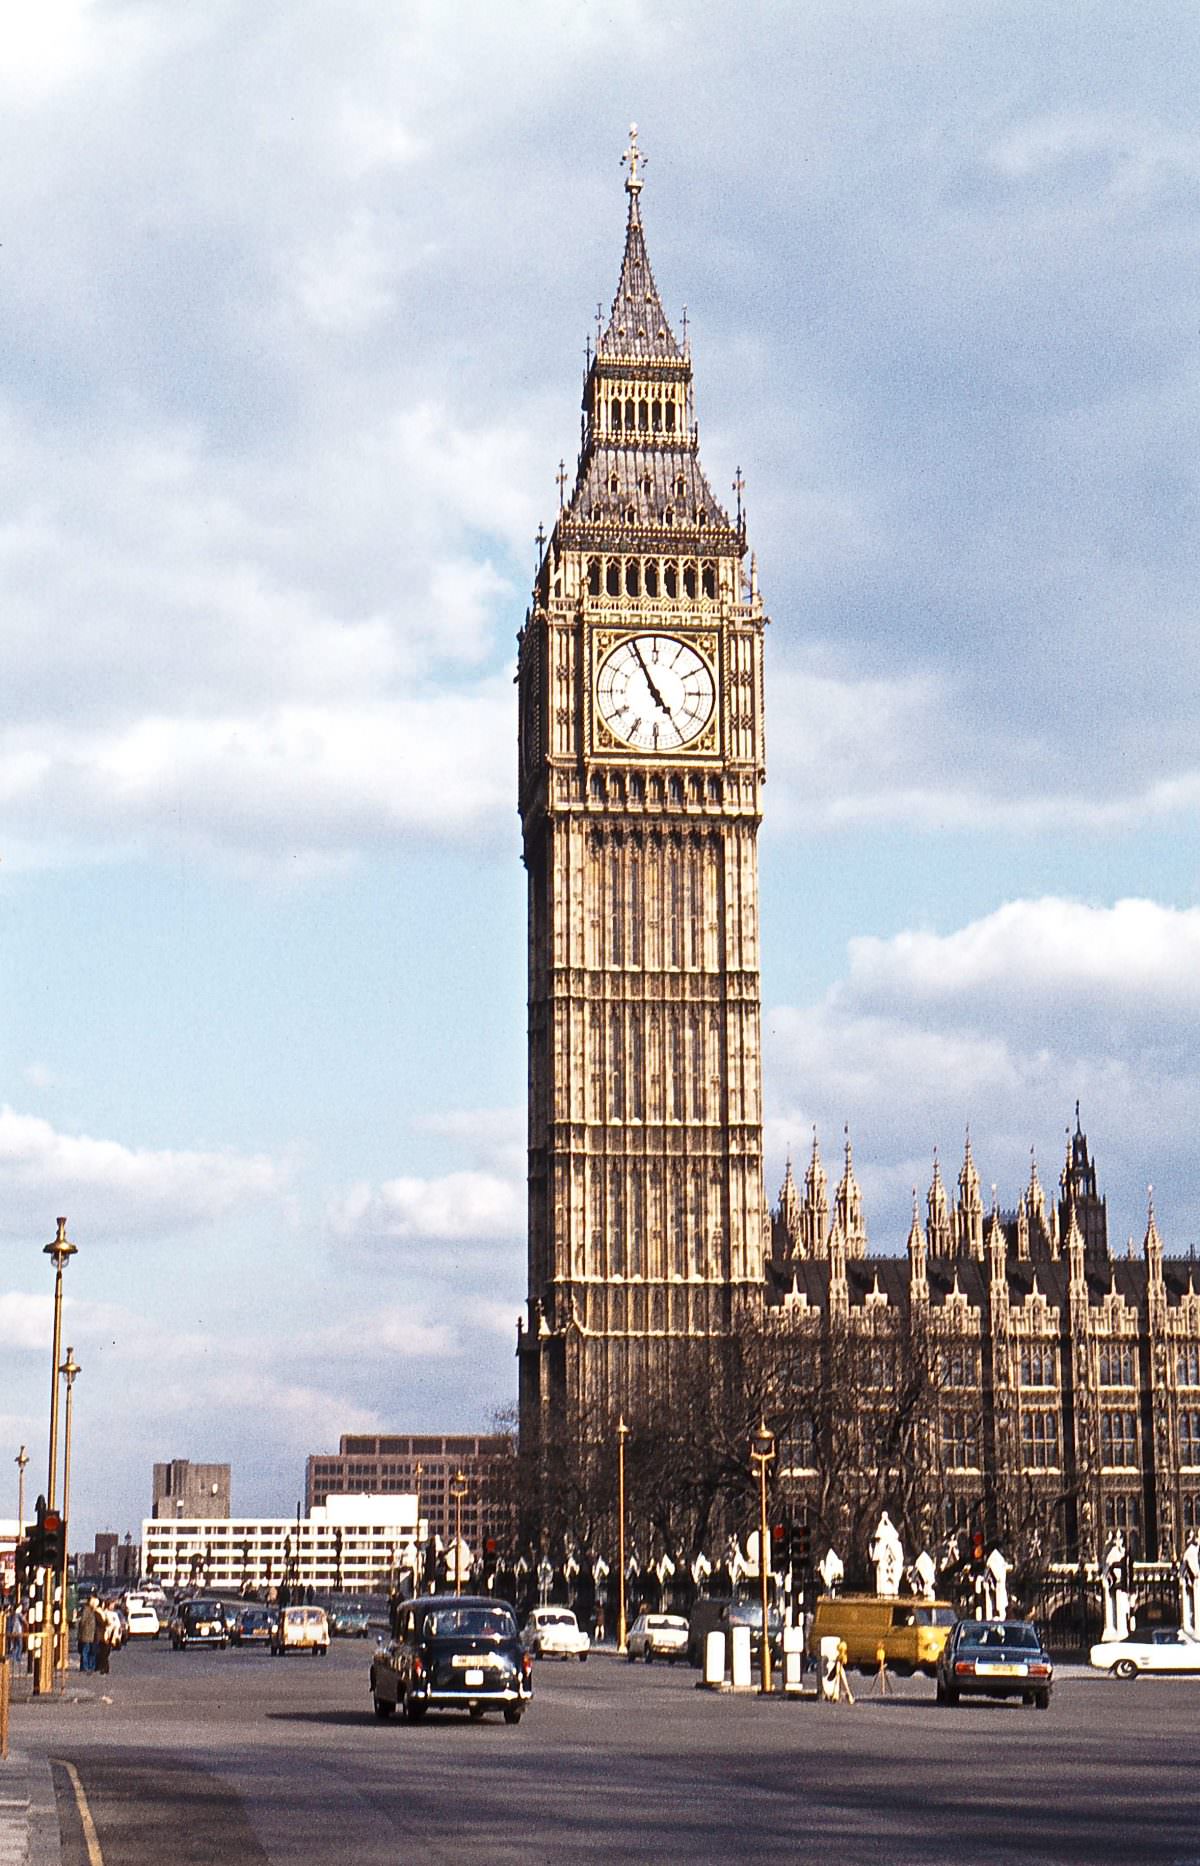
<box><xmin>142</xmin><ymin>1497</ymin><xmax>426</xmax><ymax>1594</ymax></box>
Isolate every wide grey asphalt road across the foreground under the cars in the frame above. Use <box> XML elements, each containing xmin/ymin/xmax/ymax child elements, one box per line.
<box><xmin>13</xmin><ymin>1640</ymin><xmax>1200</xmax><ymax>1866</ymax></box>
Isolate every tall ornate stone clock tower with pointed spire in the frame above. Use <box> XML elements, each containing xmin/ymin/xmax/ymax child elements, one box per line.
<box><xmin>519</xmin><ymin>129</ymin><xmax>767</xmax><ymax>1500</ymax></box>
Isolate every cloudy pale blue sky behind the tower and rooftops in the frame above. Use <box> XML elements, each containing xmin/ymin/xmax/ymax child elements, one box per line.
<box><xmin>0</xmin><ymin>0</ymin><xmax>1200</xmax><ymax>1538</ymax></box>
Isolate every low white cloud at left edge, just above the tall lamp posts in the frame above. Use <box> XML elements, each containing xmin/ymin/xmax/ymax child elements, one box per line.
<box><xmin>0</xmin><ymin>1107</ymin><xmax>286</xmax><ymax>1237</ymax></box>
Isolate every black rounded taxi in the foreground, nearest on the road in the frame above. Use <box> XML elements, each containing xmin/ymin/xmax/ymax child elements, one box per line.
<box><xmin>370</xmin><ymin>1594</ymin><xmax>534</xmax><ymax>1724</ymax></box>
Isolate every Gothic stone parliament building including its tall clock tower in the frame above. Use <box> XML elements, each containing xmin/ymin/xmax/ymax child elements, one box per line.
<box><xmin>517</xmin><ymin>132</ymin><xmax>1200</xmax><ymax>1556</ymax></box>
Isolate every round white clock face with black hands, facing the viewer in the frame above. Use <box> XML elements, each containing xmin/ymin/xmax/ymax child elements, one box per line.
<box><xmin>595</xmin><ymin>634</ymin><xmax>717</xmax><ymax>752</ymax></box>
